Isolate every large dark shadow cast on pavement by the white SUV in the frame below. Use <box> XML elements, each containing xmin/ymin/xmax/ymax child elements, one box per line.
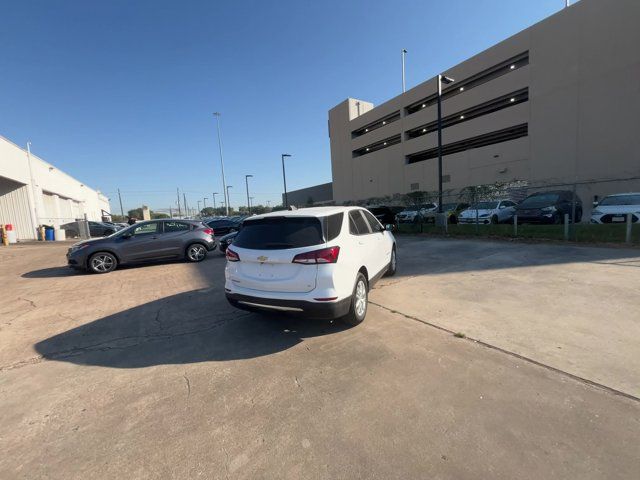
<box><xmin>35</xmin><ymin>288</ymin><xmax>348</xmax><ymax>368</ymax></box>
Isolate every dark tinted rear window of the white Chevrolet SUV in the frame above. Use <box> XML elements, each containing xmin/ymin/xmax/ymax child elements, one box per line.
<box><xmin>233</xmin><ymin>217</ymin><xmax>324</xmax><ymax>250</ymax></box>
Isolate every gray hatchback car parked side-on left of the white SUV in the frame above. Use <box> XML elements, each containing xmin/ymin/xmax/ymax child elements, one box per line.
<box><xmin>67</xmin><ymin>219</ymin><xmax>216</xmax><ymax>273</ymax></box>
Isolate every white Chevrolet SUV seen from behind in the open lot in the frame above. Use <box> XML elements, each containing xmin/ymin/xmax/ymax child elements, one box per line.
<box><xmin>225</xmin><ymin>207</ymin><xmax>396</xmax><ymax>325</ymax></box>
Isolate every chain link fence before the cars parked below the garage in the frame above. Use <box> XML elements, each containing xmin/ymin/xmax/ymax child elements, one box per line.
<box><xmin>359</xmin><ymin>178</ymin><xmax>640</xmax><ymax>245</ymax></box>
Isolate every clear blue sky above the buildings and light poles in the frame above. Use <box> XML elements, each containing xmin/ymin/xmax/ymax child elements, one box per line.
<box><xmin>0</xmin><ymin>0</ymin><xmax>564</xmax><ymax>213</ymax></box>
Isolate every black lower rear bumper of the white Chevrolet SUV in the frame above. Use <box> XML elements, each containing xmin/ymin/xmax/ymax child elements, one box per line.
<box><xmin>225</xmin><ymin>292</ymin><xmax>351</xmax><ymax>320</ymax></box>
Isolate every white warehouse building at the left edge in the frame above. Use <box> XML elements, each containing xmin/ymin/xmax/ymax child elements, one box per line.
<box><xmin>0</xmin><ymin>136</ymin><xmax>110</xmax><ymax>240</ymax></box>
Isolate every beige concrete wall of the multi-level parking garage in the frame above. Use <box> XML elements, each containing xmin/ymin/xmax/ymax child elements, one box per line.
<box><xmin>329</xmin><ymin>0</ymin><xmax>640</xmax><ymax>208</ymax></box>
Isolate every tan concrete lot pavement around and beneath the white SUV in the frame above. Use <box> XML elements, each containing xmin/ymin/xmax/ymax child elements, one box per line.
<box><xmin>0</xmin><ymin>238</ymin><xmax>640</xmax><ymax>479</ymax></box>
